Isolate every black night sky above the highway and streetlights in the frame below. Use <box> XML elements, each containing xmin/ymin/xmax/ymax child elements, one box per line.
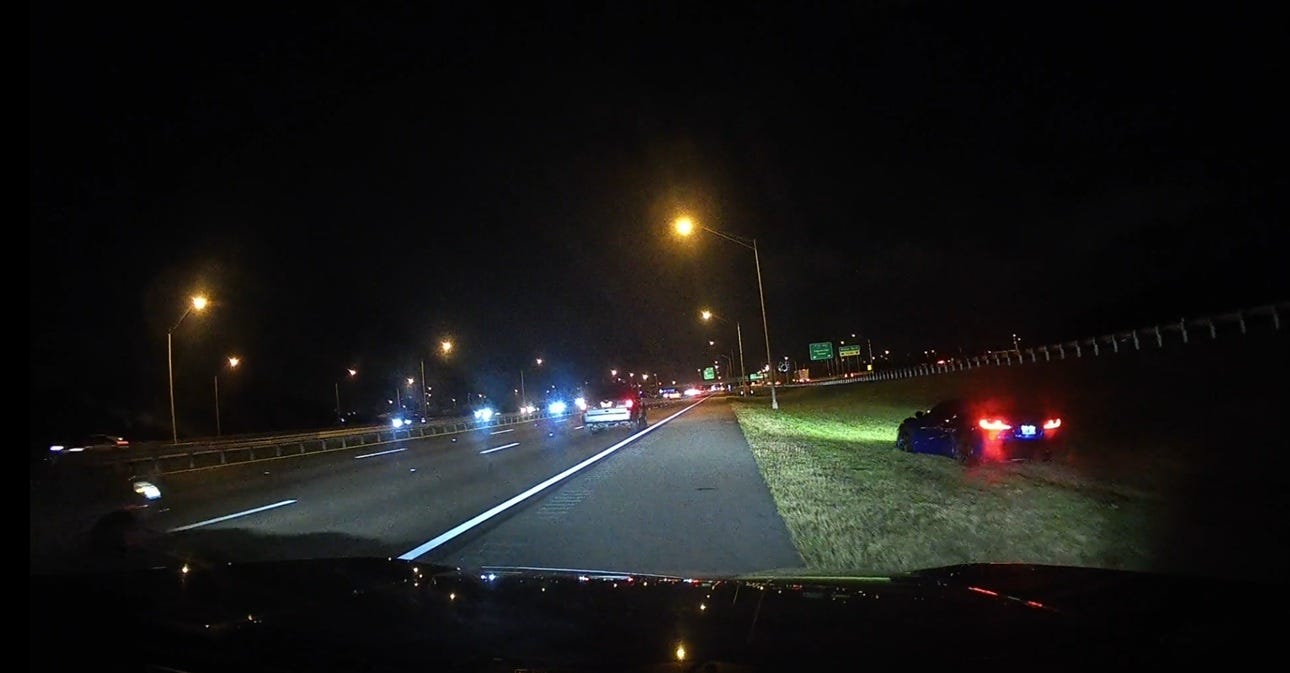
<box><xmin>30</xmin><ymin>1</ymin><xmax>1290</xmax><ymax>441</ymax></box>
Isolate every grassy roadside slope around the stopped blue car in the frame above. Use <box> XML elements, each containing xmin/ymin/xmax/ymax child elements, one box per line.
<box><xmin>733</xmin><ymin>338</ymin><xmax>1290</xmax><ymax>575</ymax></box>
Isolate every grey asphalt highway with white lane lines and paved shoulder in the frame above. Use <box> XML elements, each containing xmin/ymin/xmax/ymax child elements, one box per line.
<box><xmin>32</xmin><ymin>398</ymin><xmax>801</xmax><ymax>575</ymax></box>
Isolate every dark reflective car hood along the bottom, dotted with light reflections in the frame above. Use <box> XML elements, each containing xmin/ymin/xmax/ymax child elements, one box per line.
<box><xmin>31</xmin><ymin>558</ymin><xmax>1286</xmax><ymax>670</ymax></box>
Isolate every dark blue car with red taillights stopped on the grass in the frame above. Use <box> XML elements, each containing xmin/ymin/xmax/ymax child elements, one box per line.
<box><xmin>895</xmin><ymin>400</ymin><xmax>1062</xmax><ymax>465</ymax></box>
